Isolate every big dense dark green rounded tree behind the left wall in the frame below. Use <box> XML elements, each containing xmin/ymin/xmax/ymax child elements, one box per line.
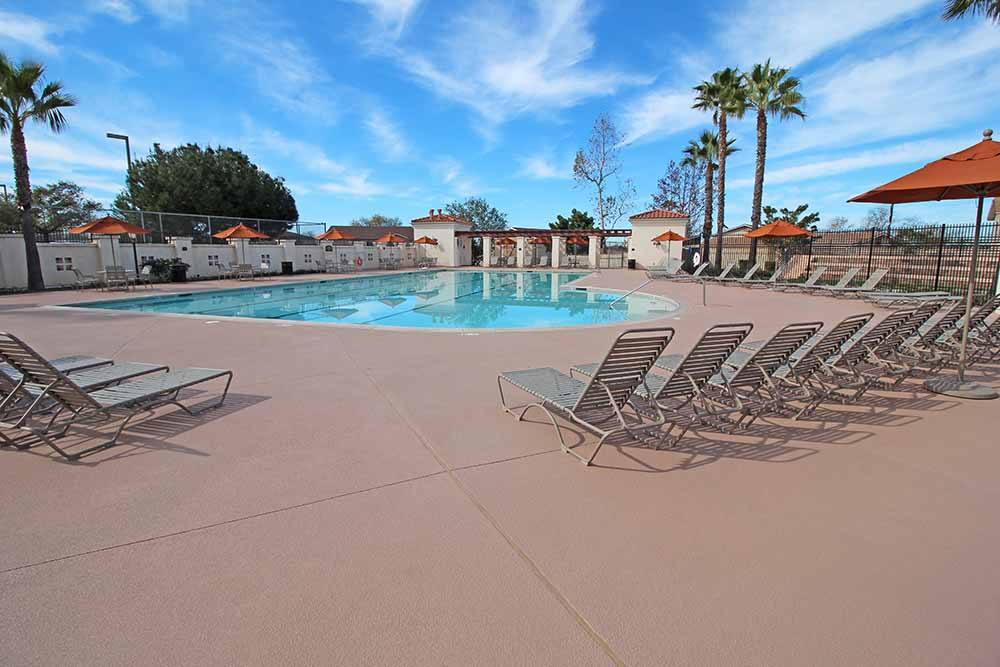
<box><xmin>115</xmin><ymin>144</ymin><xmax>299</xmax><ymax>235</ymax></box>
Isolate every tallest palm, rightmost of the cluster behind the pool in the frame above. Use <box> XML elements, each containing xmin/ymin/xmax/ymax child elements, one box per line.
<box><xmin>744</xmin><ymin>59</ymin><xmax>806</xmax><ymax>266</ymax></box>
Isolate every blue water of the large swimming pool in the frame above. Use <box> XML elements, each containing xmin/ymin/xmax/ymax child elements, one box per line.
<box><xmin>72</xmin><ymin>271</ymin><xmax>677</xmax><ymax>329</ymax></box>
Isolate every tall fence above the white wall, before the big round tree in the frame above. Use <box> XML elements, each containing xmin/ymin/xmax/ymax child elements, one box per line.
<box><xmin>37</xmin><ymin>209</ymin><xmax>327</xmax><ymax>244</ymax></box>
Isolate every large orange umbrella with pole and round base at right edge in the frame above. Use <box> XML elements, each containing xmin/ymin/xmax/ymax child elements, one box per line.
<box><xmin>849</xmin><ymin>130</ymin><xmax>1000</xmax><ymax>398</ymax></box>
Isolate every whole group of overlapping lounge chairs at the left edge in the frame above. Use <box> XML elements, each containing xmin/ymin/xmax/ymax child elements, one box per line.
<box><xmin>0</xmin><ymin>332</ymin><xmax>233</xmax><ymax>461</ymax></box>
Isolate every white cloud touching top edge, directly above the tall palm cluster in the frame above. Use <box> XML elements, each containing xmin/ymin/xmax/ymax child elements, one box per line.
<box><xmin>717</xmin><ymin>0</ymin><xmax>939</xmax><ymax>67</ymax></box>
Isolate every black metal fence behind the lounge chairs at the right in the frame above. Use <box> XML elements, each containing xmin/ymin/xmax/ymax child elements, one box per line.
<box><xmin>687</xmin><ymin>222</ymin><xmax>1000</xmax><ymax>297</ymax></box>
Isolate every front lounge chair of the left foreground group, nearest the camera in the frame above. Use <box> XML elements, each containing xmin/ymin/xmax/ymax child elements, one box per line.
<box><xmin>0</xmin><ymin>332</ymin><xmax>233</xmax><ymax>461</ymax></box>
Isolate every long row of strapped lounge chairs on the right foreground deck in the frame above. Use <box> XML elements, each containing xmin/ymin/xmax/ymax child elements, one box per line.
<box><xmin>497</xmin><ymin>297</ymin><xmax>1000</xmax><ymax>465</ymax></box>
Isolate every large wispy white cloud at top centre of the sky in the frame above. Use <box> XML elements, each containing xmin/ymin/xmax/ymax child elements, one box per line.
<box><xmin>376</xmin><ymin>0</ymin><xmax>648</xmax><ymax>125</ymax></box>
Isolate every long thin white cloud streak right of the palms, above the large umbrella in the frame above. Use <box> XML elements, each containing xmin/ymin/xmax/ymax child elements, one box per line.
<box><xmin>727</xmin><ymin>137</ymin><xmax>974</xmax><ymax>188</ymax></box>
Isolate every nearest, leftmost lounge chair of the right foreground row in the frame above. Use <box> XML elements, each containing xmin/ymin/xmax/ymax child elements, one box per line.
<box><xmin>497</xmin><ymin>327</ymin><xmax>674</xmax><ymax>465</ymax></box>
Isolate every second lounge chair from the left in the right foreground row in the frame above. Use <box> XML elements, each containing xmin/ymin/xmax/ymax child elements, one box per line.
<box><xmin>570</xmin><ymin>323</ymin><xmax>753</xmax><ymax>448</ymax></box>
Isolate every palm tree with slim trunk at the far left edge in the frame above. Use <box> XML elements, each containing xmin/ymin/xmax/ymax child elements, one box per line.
<box><xmin>0</xmin><ymin>53</ymin><xmax>76</xmax><ymax>291</ymax></box>
